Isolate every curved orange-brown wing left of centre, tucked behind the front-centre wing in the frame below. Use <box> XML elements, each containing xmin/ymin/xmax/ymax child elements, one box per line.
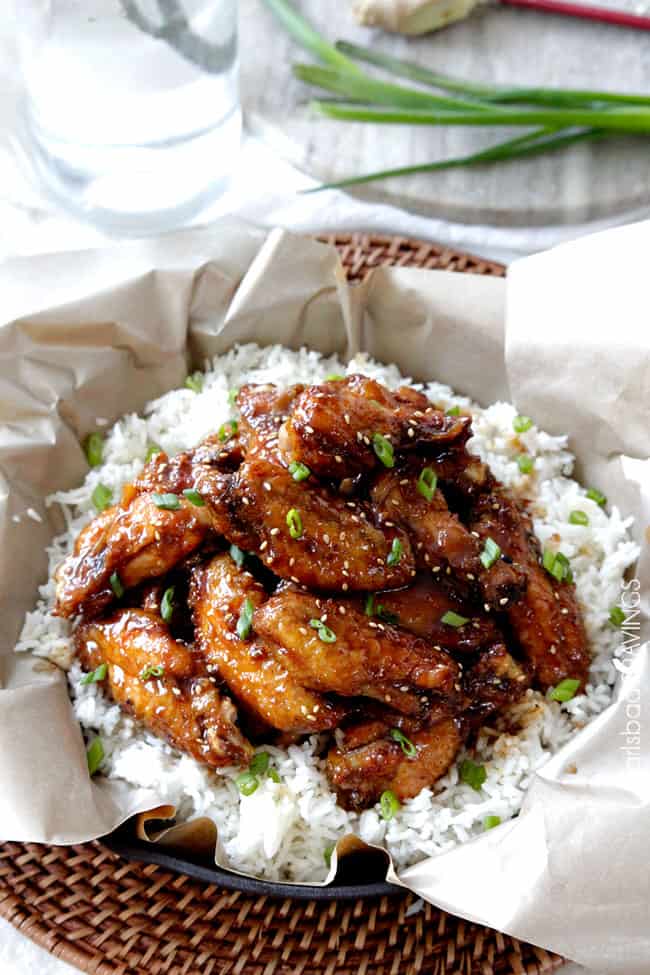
<box><xmin>190</xmin><ymin>555</ymin><xmax>345</xmax><ymax>734</ymax></box>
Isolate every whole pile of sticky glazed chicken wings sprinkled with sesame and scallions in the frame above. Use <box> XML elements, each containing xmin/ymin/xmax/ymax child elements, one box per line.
<box><xmin>57</xmin><ymin>375</ymin><xmax>589</xmax><ymax>809</ymax></box>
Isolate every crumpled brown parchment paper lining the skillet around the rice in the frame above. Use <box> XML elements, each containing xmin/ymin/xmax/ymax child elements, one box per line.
<box><xmin>0</xmin><ymin>222</ymin><xmax>650</xmax><ymax>975</ymax></box>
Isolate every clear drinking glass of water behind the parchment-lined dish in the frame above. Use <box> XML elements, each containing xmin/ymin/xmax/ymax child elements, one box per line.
<box><xmin>13</xmin><ymin>0</ymin><xmax>241</xmax><ymax>234</ymax></box>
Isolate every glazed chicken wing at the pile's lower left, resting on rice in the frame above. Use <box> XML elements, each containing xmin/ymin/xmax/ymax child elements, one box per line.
<box><xmin>75</xmin><ymin>610</ymin><xmax>252</xmax><ymax>768</ymax></box>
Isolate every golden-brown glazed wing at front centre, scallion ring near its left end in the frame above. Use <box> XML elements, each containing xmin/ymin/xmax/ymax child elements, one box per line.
<box><xmin>253</xmin><ymin>586</ymin><xmax>458</xmax><ymax>714</ymax></box>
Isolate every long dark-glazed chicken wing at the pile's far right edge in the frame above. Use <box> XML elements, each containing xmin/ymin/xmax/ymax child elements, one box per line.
<box><xmin>472</xmin><ymin>488</ymin><xmax>590</xmax><ymax>689</ymax></box>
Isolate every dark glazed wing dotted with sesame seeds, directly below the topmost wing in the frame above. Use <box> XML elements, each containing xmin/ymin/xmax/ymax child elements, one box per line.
<box><xmin>197</xmin><ymin>456</ymin><xmax>415</xmax><ymax>592</ymax></box>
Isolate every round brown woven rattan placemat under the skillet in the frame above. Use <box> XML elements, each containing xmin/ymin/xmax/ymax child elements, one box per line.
<box><xmin>0</xmin><ymin>234</ymin><xmax>562</xmax><ymax>975</ymax></box>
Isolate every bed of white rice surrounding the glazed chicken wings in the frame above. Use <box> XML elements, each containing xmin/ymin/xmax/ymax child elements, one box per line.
<box><xmin>16</xmin><ymin>345</ymin><xmax>638</xmax><ymax>881</ymax></box>
